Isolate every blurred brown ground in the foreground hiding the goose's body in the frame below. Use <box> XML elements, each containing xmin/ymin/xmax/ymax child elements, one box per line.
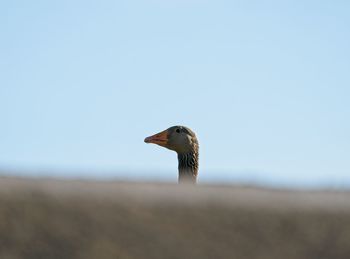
<box><xmin>0</xmin><ymin>177</ymin><xmax>350</xmax><ymax>259</ymax></box>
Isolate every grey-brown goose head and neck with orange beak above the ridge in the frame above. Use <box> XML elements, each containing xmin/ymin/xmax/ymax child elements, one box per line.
<box><xmin>145</xmin><ymin>126</ymin><xmax>199</xmax><ymax>184</ymax></box>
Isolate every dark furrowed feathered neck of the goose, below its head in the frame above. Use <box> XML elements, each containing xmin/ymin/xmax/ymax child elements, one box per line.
<box><xmin>177</xmin><ymin>149</ymin><xmax>199</xmax><ymax>183</ymax></box>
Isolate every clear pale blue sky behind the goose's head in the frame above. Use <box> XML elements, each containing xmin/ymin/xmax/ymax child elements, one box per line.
<box><xmin>0</xmin><ymin>0</ymin><xmax>350</xmax><ymax>186</ymax></box>
